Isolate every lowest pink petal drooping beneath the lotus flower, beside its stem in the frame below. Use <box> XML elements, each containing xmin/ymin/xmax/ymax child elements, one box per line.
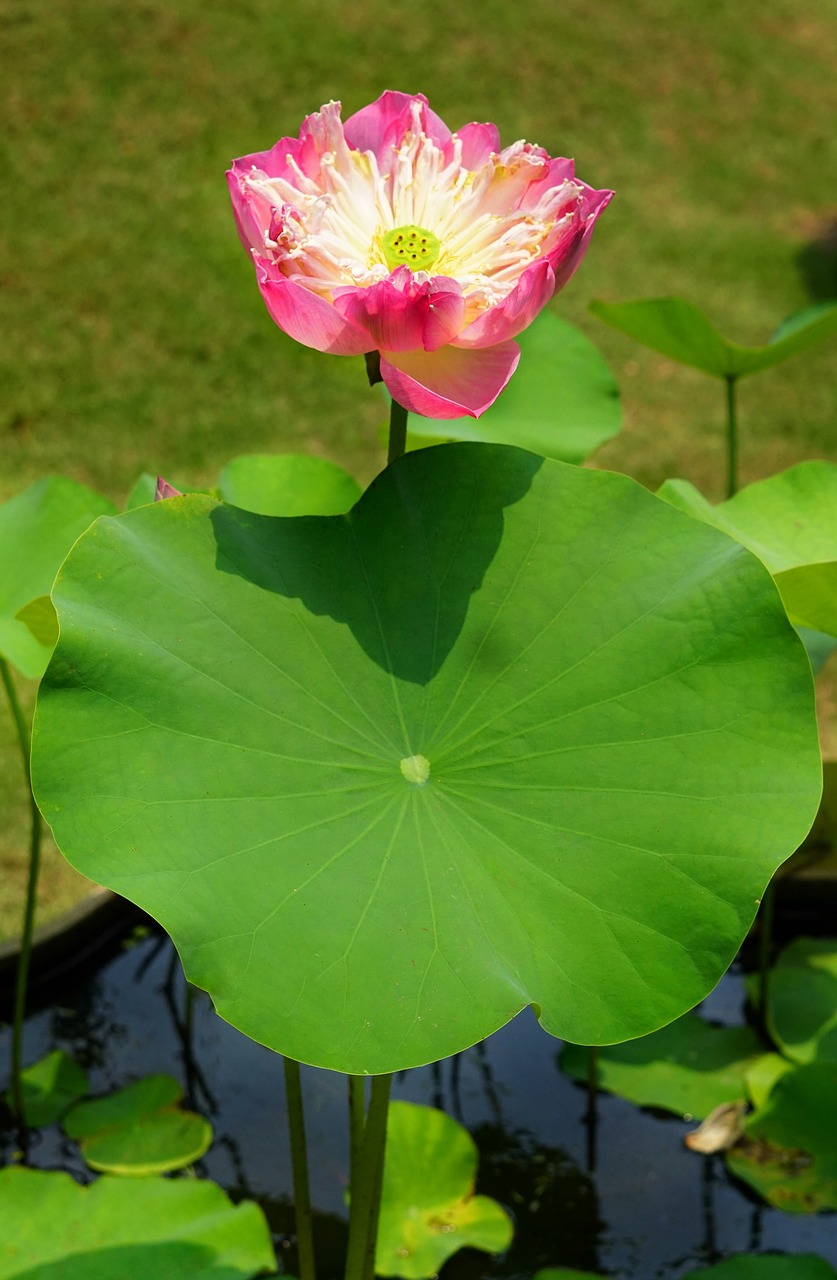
<box><xmin>380</xmin><ymin>342</ymin><xmax>520</xmax><ymax>419</ymax></box>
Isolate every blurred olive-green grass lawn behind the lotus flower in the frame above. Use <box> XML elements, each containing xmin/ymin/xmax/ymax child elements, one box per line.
<box><xmin>0</xmin><ymin>0</ymin><xmax>837</xmax><ymax>931</ymax></box>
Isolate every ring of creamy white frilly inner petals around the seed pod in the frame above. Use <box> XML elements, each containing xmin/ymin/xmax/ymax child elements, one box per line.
<box><xmin>244</xmin><ymin>113</ymin><xmax>582</xmax><ymax>314</ymax></box>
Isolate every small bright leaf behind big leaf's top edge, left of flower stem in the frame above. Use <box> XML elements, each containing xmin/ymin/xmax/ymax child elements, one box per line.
<box><xmin>218</xmin><ymin>453</ymin><xmax>361</xmax><ymax>516</ymax></box>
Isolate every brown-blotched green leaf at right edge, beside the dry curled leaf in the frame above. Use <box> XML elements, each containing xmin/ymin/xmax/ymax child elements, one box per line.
<box><xmin>727</xmin><ymin>1062</ymin><xmax>837</xmax><ymax>1213</ymax></box>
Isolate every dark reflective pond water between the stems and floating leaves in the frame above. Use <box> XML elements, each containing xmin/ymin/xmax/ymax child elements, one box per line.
<box><xmin>0</xmin><ymin>933</ymin><xmax>837</xmax><ymax>1280</ymax></box>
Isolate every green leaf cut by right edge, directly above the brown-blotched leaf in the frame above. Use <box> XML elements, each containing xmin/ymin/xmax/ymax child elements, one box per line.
<box><xmin>768</xmin><ymin>938</ymin><xmax>837</xmax><ymax>1062</ymax></box>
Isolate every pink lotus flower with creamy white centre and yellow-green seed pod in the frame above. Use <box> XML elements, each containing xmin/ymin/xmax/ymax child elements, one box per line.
<box><xmin>228</xmin><ymin>92</ymin><xmax>612</xmax><ymax>419</ymax></box>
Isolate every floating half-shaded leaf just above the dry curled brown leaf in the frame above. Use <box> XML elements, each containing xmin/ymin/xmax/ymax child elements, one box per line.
<box><xmin>561</xmin><ymin>1014</ymin><xmax>764</xmax><ymax>1120</ymax></box>
